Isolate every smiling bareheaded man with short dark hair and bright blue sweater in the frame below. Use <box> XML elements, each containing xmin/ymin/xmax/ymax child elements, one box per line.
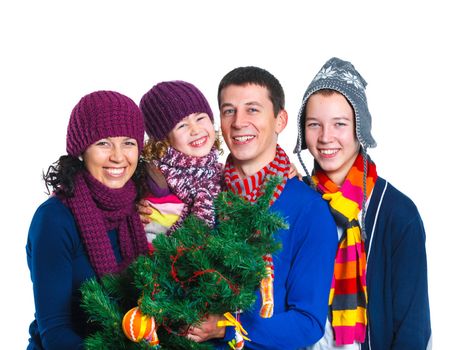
<box><xmin>187</xmin><ymin>67</ymin><xmax>337</xmax><ymax>349</ymax></box>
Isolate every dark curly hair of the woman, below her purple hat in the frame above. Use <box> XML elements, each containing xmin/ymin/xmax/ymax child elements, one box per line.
<box><xmin>42</xmin><ymin>155</ymin><xmax>148</xmax><ymax>201</ymax></box>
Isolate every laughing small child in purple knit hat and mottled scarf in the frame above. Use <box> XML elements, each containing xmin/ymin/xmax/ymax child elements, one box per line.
<box><xmin>140</xmin><ymin>81</ymin><xmax>223</xmax><ymax>249</ymax></box>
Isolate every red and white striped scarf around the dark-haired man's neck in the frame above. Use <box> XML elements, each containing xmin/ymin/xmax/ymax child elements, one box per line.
<box><xmin>224</xmin><ymin>145</ymin><xmax>290</xmax><ymax>318</ymax></box>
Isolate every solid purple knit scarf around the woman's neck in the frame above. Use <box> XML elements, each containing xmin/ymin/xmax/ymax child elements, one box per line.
<box><xmin>65</xmin><ymin>171</ymin><xmax>148</xmax><ymax>277</ymax></box>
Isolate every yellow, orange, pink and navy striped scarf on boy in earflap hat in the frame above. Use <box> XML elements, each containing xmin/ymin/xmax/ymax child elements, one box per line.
<box><xmin>312</xmin><ymin>154</ymin><xmax>377</xmax><ymax>346</ymax></box>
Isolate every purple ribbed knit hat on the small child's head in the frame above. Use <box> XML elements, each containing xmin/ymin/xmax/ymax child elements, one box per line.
<box><xmin>140</xmin><ymin>80</ymin><xmax>214</xmax><ymax>141</ymax></box>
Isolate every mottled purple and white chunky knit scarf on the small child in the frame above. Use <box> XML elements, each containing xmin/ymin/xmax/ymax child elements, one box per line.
<box><xmin>154</xmin><ymin>147</ymin><xmax>223</xmax><ymax>232</ymax></box>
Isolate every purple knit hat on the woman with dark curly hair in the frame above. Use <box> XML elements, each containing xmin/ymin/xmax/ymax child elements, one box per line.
<box><xmin>66</xmin><ymin>91</ymin><xmax>144</xmax><ymax>157</ymax></box>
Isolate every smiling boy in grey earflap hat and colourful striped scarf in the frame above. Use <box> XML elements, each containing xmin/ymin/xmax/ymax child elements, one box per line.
<box><xmin>295</xmin><ymin>58</ymin><xmax>431</xmax><ymax>350</ymax></box>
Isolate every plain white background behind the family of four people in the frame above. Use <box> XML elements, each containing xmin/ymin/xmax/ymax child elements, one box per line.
<box><xmin>0</xmin><ymin>0</ymin><xmax>449</xmax><ymax>349</ymax></box>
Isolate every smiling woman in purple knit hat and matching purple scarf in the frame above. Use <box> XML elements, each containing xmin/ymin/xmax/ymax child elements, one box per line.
<box><xmin>26</xmin><ymin>91</ymin><xmax>148</xmax><ymax>349</ymax></box>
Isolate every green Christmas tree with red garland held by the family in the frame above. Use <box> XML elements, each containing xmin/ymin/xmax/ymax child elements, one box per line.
<box><xmin>81</xmin><ymin>177</ymin><xmax>287</xmax><ymax>350</ymax></box>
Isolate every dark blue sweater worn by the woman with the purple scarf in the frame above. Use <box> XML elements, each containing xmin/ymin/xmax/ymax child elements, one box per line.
<box><xmin>26</xmin><ymin>197</ymin><xmax>121</xmax><ymax>350</ymax></box>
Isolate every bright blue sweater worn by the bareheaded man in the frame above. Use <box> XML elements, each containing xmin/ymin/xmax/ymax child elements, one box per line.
<box><xmin>215</xmin><ymin>178</ymin><xmax>337</xmax><ymax>350</ymax></box>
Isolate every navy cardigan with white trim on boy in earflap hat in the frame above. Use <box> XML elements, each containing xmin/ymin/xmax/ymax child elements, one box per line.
<box><xmin>362</xmin><ymin>178</ymin><xmax>431</xmax><ymax>350</ymax></box>
